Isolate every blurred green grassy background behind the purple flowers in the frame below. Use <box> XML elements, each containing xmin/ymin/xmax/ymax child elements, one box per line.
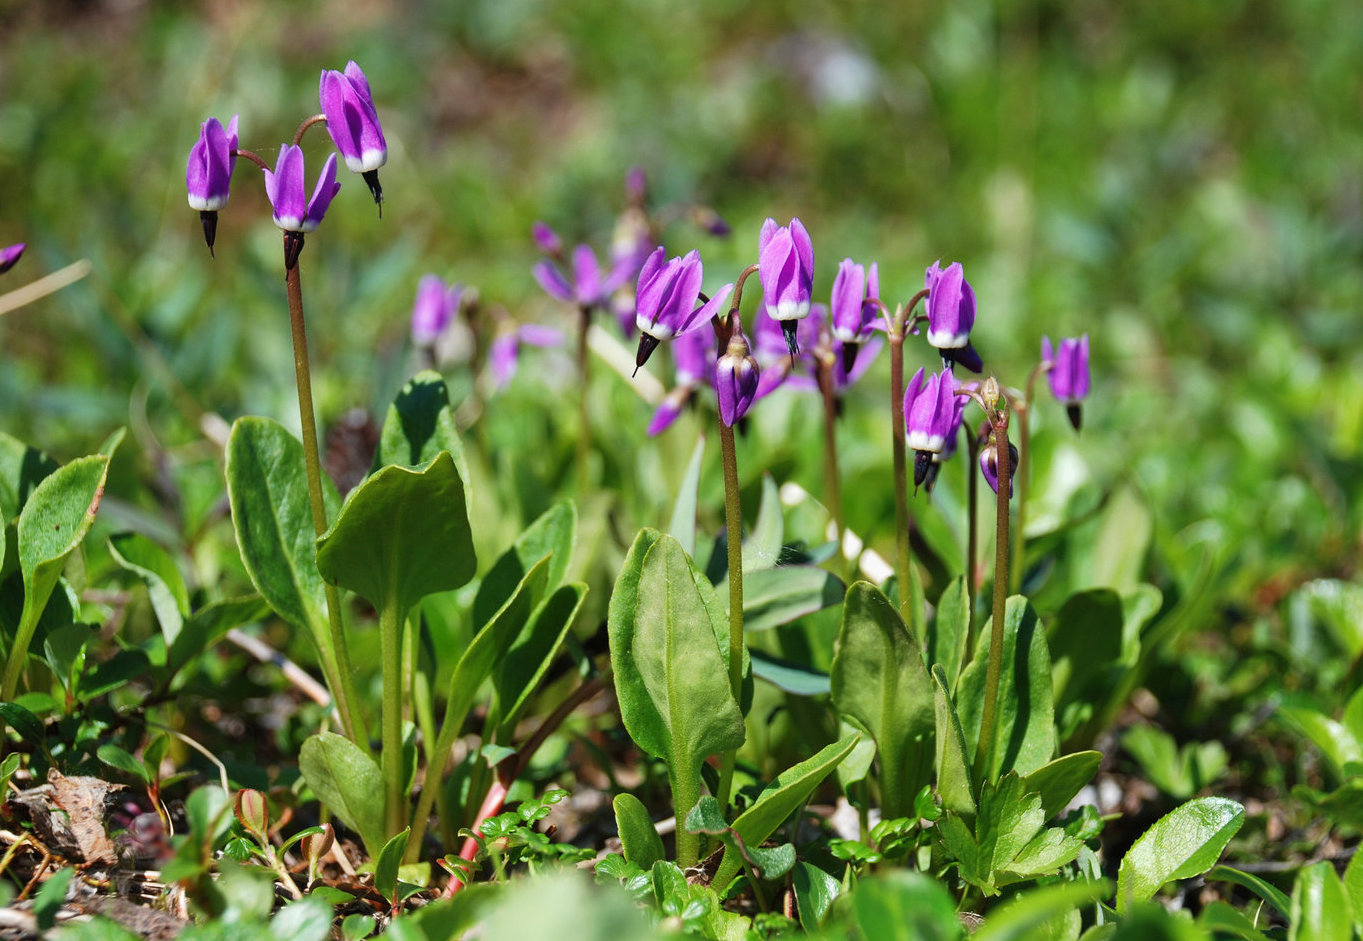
<box><xmin>0</xmin><ymin>0</ymin><xmax>1363</xmax><ymax>608</ymax></box>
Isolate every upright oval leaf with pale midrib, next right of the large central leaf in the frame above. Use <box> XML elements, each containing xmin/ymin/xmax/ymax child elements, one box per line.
<box><xmin>831</xmin><ymin>581</ymin><xmax>935</xmax><ymax>817</ymax></box>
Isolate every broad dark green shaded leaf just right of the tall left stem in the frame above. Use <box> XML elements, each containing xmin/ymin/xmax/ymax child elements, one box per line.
<box><xmin>318</xmin><ymin>451</ymin><xmax>477</xmax><ymax>619</ymax></box>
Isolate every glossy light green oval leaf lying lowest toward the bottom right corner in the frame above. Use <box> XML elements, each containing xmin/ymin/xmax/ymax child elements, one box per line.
<box><xmin>1116</xmin><ymin>798</ymin><xmax>1244</xmax><ymax>912</ymax></box>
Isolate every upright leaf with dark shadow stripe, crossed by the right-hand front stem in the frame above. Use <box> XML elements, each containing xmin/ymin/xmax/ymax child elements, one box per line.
<box><xmin>955</xmin><ymin>595</ymin><xmax>1056</xmax><ymax>780</ymax></box>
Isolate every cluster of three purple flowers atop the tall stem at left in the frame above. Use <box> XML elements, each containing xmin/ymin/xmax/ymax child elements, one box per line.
<box><xmin>184</xmin><ymin>61</ymin><xmax>388</xmax><ymax>260</ymax></box>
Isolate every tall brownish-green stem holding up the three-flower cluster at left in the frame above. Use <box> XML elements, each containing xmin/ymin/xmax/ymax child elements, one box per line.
<box><xmin>284</xmin><ymin>252</ymin><xmax>362</xmax><ymax>741</ymax></box>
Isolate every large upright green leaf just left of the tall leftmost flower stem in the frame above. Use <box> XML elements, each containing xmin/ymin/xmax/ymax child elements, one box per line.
<box><xmin>226</xmin><ymin>417</ymin><xmax>341</xmax><ymax>638</ymax></box>
